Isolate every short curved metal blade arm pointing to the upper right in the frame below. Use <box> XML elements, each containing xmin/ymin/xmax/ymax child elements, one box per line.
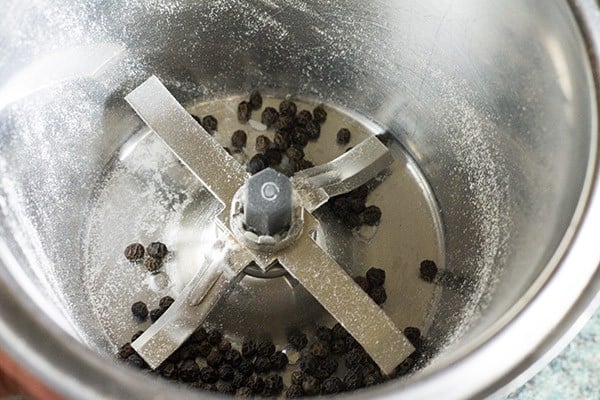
<box><xmin>291</xmin><ymin>136</ymin><xmax>394</xmax><ymax>212</ymax></box>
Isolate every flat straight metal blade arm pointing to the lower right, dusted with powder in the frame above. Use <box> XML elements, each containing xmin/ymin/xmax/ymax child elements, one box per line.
<box><xmin>278</xmin><ymin>214</ymin><xmax>415</xmax><ymax>374</ymax></box>
